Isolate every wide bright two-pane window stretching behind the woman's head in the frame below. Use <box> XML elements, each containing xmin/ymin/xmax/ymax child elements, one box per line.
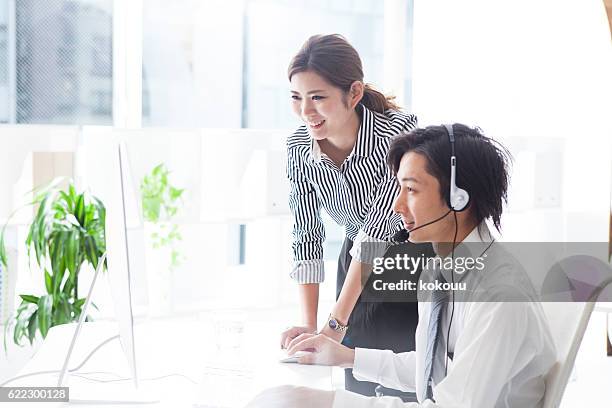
<box><xmin>142</xmin><ymin>0</ymin><xmax>404</xmax><ymax>129</ymax></box>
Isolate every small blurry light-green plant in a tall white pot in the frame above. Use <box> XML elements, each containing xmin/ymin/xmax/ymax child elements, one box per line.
<box><xmin>140</xmin><ymin>163</ymin><xmax>185</xmax><ymax>315</ymax></box>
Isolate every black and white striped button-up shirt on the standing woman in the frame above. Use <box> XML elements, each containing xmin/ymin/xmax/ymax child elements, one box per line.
<box><xmin>287</xmin><ymin>105</ymin><xmax>416</xmax><ymax>283</ymax></box>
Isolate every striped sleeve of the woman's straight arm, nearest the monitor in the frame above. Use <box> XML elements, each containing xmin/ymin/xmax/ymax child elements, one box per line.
<box><xmin>287</xmin><ymin>149</ymin><xmax>325</xmax><ymax>283</ymax></box>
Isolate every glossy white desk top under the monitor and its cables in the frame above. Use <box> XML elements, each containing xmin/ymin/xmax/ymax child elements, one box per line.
<box><xmin>3</xmin><ymin>316</ymin><xmax>332</xmax><ymax>408</ymax></box>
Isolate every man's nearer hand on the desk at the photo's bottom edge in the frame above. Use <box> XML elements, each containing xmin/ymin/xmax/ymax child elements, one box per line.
<box><xmin>246</xmin><ymin>385</ymin><xmax>334</xmax><ymax>408</ymax></box>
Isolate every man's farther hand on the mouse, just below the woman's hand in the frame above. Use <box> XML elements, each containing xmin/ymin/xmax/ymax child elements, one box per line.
<box><xmin>287</xmin><ymin>333</ymin><xmax>355</xmax><ymax>368</ymax></box>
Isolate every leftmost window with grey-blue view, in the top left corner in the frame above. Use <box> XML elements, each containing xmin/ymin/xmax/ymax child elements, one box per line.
<box><xmin>0</xmin><ymin>0</ymin><xmax>112</xmax><ymax>125</ymax></box>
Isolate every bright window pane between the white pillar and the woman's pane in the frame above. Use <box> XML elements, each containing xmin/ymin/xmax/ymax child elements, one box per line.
<box><xmin>142</xmin><ymin>0</ymin><xmax>244</xmax><ymax>128</ymax></box>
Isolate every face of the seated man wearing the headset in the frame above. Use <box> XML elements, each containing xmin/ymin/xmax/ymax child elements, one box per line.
<box><xmin>393</xmin><ymin>152</ymin><xmax>455</xmax><ymax>242</ymax></box>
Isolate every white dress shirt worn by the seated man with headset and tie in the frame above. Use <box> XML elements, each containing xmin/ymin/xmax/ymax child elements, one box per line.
<box><xmin>333</xmin><ymin>223</ymin><xmax>556</xmax><ymax>408</ymax></box>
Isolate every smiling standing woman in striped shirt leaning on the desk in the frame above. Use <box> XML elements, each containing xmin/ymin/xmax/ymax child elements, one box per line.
<box><xmin>281</xmin><ymin>34</ymin><xmax>432</xmax><ymax>395</ymax></box>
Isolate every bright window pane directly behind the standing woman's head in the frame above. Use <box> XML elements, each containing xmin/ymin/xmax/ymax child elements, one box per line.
<box><xmin>244</xmin><ymin>0</ymin><xmax>384</xmax><ymax>129</ymax></box>
